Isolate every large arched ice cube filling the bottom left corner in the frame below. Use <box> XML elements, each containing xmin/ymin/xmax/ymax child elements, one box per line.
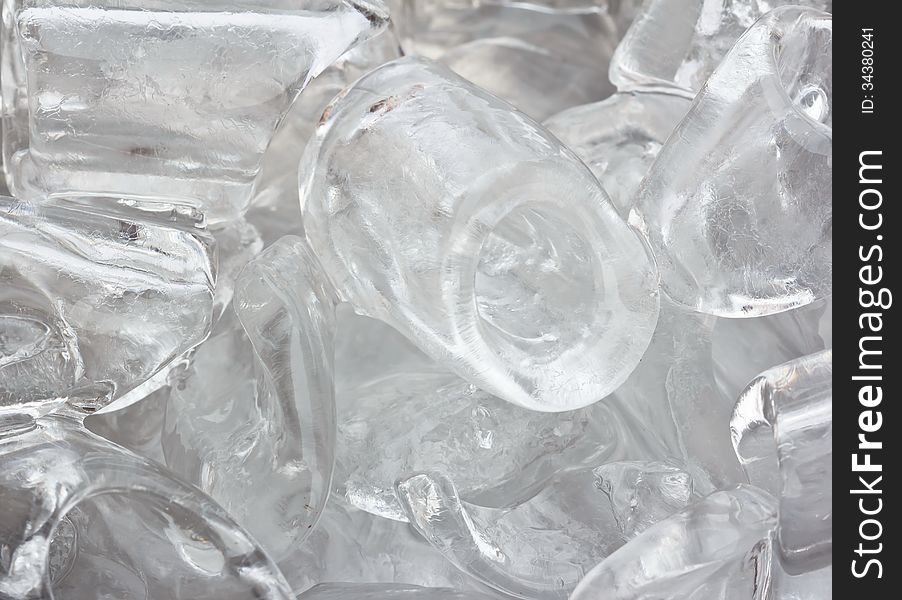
<box><xmin>0</xmin><ymin>411</ymin><xmax>292</xmax><ymax>600</ymax></box>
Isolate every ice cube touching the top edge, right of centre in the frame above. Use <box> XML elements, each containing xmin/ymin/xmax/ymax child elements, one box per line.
<box><xmin>609</xmin><ymin>0</ymin><xmax>767</xmax><ymax>98</ymax></box>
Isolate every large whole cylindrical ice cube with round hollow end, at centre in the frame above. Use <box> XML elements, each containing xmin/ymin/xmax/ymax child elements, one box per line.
<box><xmin>301</xmin><ymin>59</ymin><xmax>658</xmax><ymax>411</ymax></box>
